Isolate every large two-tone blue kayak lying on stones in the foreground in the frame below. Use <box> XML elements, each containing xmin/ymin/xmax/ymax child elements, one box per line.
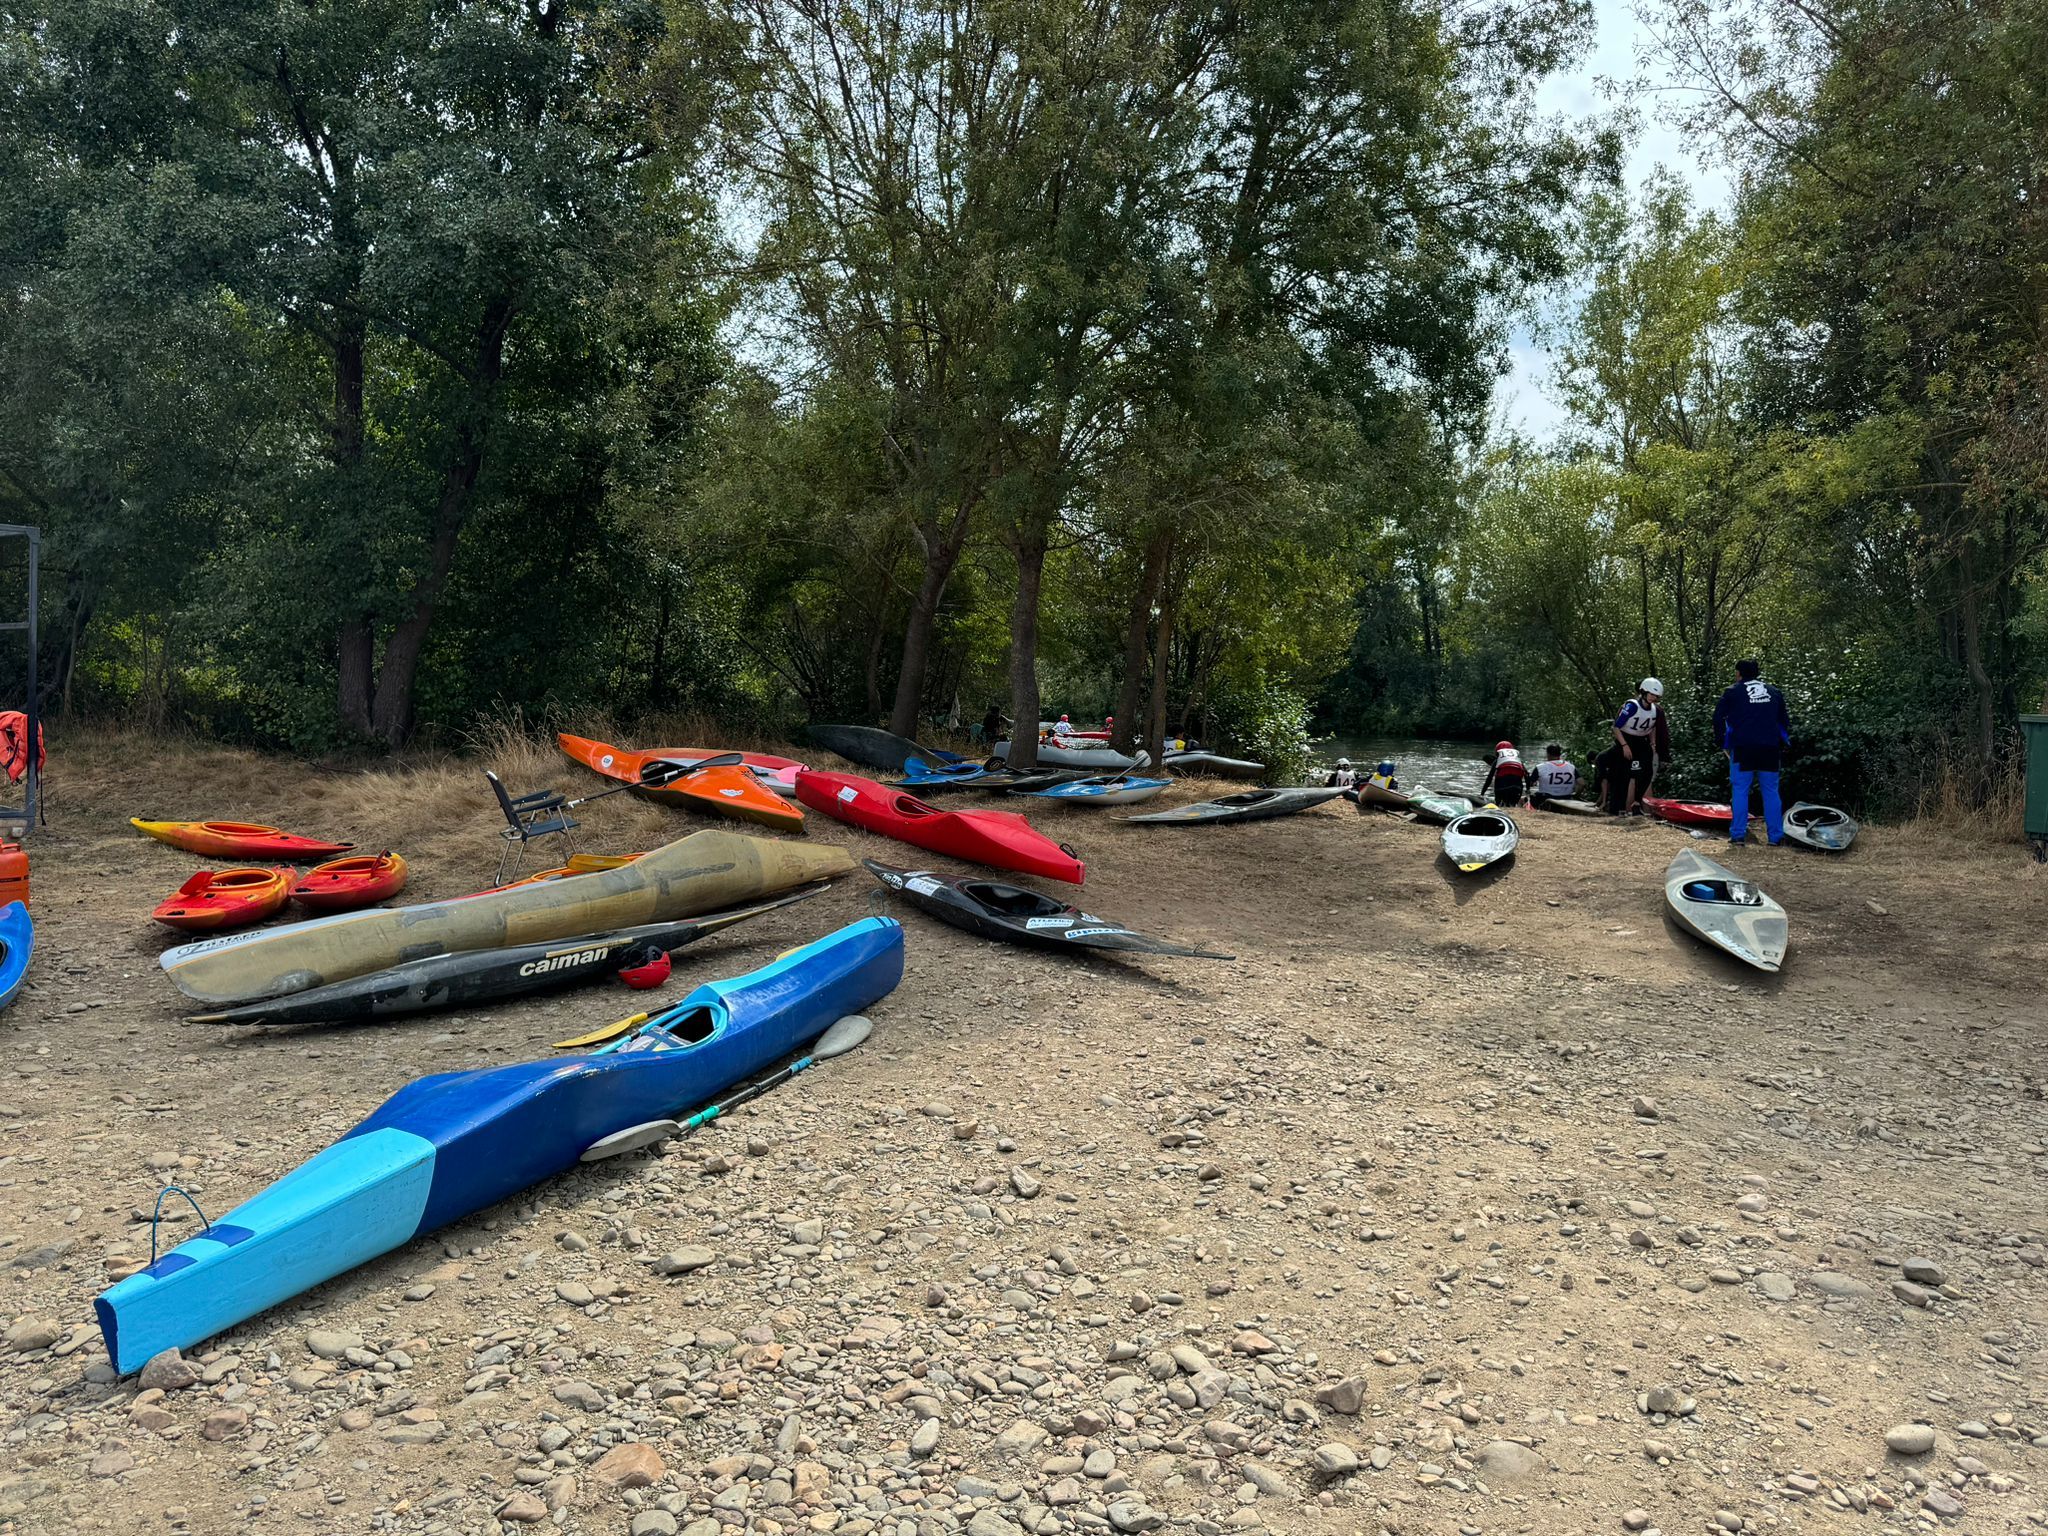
<box><xmin>92</xmin><ymin>918</ymin><xmax>903</xmax><ymax>1372</ymax></box>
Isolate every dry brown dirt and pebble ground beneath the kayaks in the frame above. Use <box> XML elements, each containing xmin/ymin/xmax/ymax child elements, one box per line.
<box><xmin>0</xmin><ymin>737</ymin><xmax>2048</xmax><ymax>1536</ymax></box>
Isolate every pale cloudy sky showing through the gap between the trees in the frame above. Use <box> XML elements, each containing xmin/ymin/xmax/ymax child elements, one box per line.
<box><xmin>1493</xmin><ymin>0</ymin><xmax>1729</xmax><ymax>440</ymax></box>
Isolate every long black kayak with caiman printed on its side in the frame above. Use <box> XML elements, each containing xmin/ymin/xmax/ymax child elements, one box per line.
<box><xmin>184</xmin><ymin>885</ymin><xmax>825</xmax><ymax>1024</ymax></box>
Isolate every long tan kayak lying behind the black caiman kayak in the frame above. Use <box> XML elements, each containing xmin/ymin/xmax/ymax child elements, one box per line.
<box><xmin>162</xmin><ymin>831</ymin><xmax>854</xmax><ymax>1006</ymax></box>
